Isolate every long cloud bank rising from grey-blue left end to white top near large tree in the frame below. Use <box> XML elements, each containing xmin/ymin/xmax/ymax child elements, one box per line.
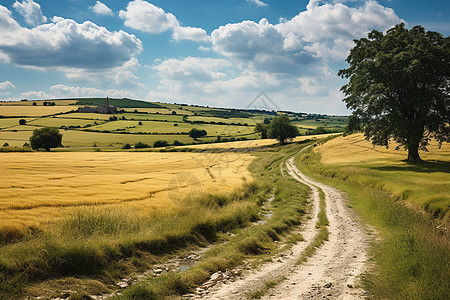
<box><xmin>211</xmin><ymin>0</ymin><xmax>402</xmax><ymax>73</ymax></box>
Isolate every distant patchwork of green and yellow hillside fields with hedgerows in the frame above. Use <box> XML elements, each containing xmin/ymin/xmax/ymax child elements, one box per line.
<box><xmin>0</xmin><ymin>98</ymin><xmax>346</xmax><ymax>149</ymax></box>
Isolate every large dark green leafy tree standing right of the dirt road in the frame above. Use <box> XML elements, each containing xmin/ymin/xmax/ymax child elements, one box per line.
<box><xmin>339</xmin><ymin>24</ymin><xmax>450</xmax><ymax>162</ymax></box>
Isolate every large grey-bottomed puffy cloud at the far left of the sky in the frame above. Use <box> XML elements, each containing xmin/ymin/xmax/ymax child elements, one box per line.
<box><xmin>0</xmin><ymin>6</ymin><xmax>142</xmax><ymax>70</ymax></box>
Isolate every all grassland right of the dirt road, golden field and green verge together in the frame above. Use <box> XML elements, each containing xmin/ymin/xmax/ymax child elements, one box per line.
<box><xmin>296</xmin><ymin>134</ymin><xmax>450</xmax><ymax>300</ymax></box>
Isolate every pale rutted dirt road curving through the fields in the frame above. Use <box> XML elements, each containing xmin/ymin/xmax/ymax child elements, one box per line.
<box><xmin>196</xmin><ymin>152</ymin><xmax>369</xmax><ymax>299</ymax></box>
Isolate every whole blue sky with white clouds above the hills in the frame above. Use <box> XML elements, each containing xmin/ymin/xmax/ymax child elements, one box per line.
<box><xmin>0</xmin><ymin>0</ymin><xmax>450</xmax><ymax>115</ymax></box>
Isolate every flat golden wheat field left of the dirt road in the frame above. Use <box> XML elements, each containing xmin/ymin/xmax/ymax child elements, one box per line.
<box><xmin>0</xmin><ymin>152</ymin><xmax>254</xmax><ymax>229</ymax></box>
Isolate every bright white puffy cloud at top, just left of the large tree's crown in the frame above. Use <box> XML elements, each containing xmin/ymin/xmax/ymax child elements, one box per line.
<box><xmin>276</xmin><ymin>0</ymin><xmax>403</xmax><ymax>60</ymax></box>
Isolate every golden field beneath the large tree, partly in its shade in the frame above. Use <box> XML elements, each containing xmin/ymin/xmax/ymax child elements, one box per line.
<box><xmin>315</xmin><ymin>134</ymin><xmax>450</xmax><ymax>223</ymax></box>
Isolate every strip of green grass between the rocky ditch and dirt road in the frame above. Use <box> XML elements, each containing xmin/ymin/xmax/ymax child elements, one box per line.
<box><xmin>110</xmin><ymin>144</ymin><xmax>308</xmax><ymax>299</ymax></box>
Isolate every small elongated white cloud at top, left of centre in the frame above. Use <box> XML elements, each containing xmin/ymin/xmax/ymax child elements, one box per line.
<box><xmin>119</xmin><ymin>0</ymin><xmax>209</xmax><ymax>42</ymax></box>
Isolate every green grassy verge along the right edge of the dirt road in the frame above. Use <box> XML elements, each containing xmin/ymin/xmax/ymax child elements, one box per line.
<box><xmin>296</xmin><ymin>144</ymin><xmax>450</xmax><ymax>299</ymax></box>
